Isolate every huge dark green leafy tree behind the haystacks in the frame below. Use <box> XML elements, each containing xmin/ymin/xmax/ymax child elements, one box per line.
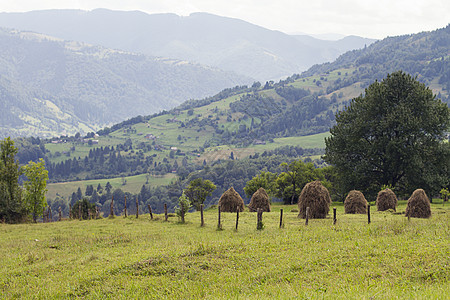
<box><xmin>324</xmin><ymin>71</ymin><xmax>450</xmax><ymax>195</ymax></box>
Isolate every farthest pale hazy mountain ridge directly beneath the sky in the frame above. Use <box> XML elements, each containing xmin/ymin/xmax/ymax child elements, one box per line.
<box><xmin>0</xmin><ymin>9</ymin><xmax>375</xmax><ymax>82</ymax></box>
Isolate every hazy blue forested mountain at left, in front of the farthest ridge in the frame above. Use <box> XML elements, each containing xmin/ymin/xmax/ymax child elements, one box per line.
<box><xmin>0</xmin><ymin>29</ymin><xmax>251</xmax><ymax>137</ymax></box>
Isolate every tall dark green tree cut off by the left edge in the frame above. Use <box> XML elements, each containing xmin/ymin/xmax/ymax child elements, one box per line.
<box><xmin>0</xmin><ymin>137</ymin><xmax>26</xmax><ymax>223</ymax></box>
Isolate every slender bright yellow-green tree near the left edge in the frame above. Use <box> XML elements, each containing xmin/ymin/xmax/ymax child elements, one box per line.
<box><xmin>23</xmin><ymin>158</ymin><xmax>48</xmax><ymax>223</ymax></box>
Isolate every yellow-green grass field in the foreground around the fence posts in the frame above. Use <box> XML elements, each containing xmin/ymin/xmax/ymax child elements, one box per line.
<box><xmin>0</xmin><ymin>201</ymin><xmax>450</xmax><ymax>299</ymax></box>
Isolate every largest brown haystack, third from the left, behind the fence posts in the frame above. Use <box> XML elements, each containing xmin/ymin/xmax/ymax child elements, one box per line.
<box><xmin>298</xmin><ymin>181</ymin><xmax>331</xmax><ymax>219</ymax></box>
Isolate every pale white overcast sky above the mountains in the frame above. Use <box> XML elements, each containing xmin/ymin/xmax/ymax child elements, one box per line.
<box><xmin>0</xmin><ymin>0</ymin><xmax>450</xmax><ymax>39</ymax></box>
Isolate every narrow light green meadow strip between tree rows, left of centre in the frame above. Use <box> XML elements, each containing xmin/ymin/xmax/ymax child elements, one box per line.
<box><xmin>47</xmin><ymin>173</ymin><xmax>176</xmax><ymax>199</ymax></box>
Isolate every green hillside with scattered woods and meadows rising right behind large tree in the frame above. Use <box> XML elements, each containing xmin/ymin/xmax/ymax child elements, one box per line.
<box><xmin>11</xmin><ymin>27</ymin><xmax>450</xmax><ymax>213</ymax></box>
